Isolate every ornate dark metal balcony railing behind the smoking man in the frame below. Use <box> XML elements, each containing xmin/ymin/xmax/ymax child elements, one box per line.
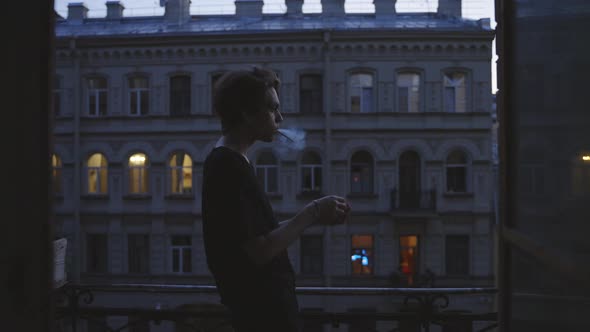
<box><xmin>55</xmin><ymin>284</ymin><xmax>498</xmax><ymax>332</ymax></box>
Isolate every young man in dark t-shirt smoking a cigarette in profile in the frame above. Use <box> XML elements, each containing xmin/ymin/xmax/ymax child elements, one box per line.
<box><xmin>202</xmin><ymin>67</ymin><xmax>350</xmax><ymax>332</ymax></box>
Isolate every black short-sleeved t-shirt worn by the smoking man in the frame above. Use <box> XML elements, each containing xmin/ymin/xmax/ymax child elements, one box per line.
<box><xmin>202</xmin><ymin>146</ymin><xmax>296</xmax><ymax>310</ymax></box>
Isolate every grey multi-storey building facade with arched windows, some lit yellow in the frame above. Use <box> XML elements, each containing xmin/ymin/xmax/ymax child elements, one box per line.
<box><xmin>52</xmin><ymin>0</ymin><xmax>495</xmax><ymax>331</ymax></box>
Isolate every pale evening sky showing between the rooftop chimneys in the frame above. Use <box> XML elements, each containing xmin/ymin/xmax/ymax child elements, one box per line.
<box><xmin>54</xmin><ymin>0</ymin><xmax>497</xmax><ymax>93</ymax></box>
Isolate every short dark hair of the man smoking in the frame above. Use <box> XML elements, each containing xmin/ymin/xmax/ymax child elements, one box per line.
<box><xmin>213</xmin><ymin>67</ymin><xmax>280</xmax><ymax>134</ymax></box>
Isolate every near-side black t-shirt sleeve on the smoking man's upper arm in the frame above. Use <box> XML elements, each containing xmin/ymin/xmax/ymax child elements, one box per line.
<box><xmin>203</xmin><ymin>154</ymin><xmax>255</xmax><ymax>244</ymax></box>
